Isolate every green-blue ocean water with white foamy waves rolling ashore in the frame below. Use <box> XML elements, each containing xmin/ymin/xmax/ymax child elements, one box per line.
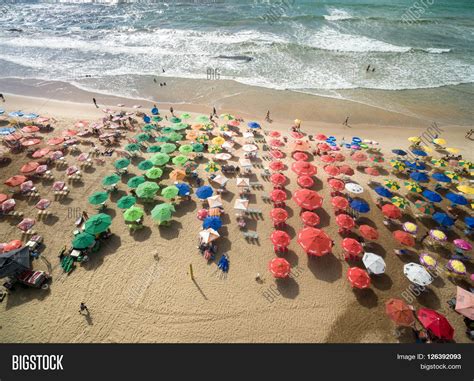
<box><xmin>0</xmin><ymin>0</ymin><xmax>474</xmax><ymax>119</ymax></box>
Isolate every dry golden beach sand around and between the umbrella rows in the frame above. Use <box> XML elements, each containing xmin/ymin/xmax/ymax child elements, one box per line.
<box><xmin>0</xmin><ymin>84</ymin><xmax>473</xmax><ymax>343</ymax></box>
